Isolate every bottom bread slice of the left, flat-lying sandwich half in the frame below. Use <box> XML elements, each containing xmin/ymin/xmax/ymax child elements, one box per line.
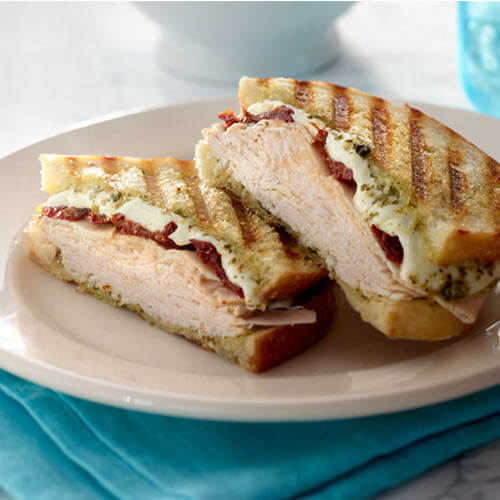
<box><xmin>29</xmin><ymin>236</ymin><xmax>335</xmax><ymax>373</ymax></box>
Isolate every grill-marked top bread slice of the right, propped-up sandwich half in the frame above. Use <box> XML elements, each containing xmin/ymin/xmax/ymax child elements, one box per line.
<box><xmin>239</xmin><ymin>77</ymin><xmax>500</xmax><ymax>265</ymax></box>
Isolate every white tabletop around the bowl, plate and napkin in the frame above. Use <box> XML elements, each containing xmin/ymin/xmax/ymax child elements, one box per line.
<box><xmin>0</xmin><ymin>2</ymin><xmax>500</xmax><ymax>500</ymax></box>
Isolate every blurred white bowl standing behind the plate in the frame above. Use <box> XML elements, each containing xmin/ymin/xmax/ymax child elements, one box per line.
<box><xmin>134</xmin><ymin>2</ymin><xmax>352</xmax><ymax>81</ymax></box>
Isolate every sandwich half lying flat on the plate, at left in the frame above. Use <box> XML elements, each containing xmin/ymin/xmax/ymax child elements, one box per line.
<box><xmin>26</xmin><ymin>155</ymin><xmax>334</xmax><ymax>372</ymax></box>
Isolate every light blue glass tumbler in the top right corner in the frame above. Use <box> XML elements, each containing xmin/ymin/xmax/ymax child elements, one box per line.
<box><xmin>458</xmin><ymin>2</ymin><xmax>500</xmax><ymax>118</ymax></box>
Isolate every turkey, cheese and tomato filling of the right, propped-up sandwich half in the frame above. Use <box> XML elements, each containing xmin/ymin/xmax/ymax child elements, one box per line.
<box><xmin>197</xmin><ymin>101</ymin><xmax>500</xmax><ymax>322</ymax></box>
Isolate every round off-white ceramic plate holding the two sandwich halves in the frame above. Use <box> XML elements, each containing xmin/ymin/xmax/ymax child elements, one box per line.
<box><xmin>0</xmin><ymin>99</ymin><xmax>500</xmax><ymax>421</ymax></box>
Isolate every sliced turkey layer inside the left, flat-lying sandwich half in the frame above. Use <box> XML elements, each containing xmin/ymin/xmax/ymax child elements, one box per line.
<box><xmin>27</xmin><ymin>215</ymin><xmax>316</xmax><ymax>337</ymax></box>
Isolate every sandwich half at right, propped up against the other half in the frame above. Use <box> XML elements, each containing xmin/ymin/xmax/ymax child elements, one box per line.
<box><xmin>196</xmin><ymin>77</ymin><xmax>500</xmax><ymax>340</ymax></box>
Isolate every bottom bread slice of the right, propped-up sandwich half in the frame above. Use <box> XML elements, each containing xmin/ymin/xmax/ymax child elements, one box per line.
<box><xmin>340</xmin><ymin>283</ymin><xmax>471</xmax><ymax>340</ymax></box>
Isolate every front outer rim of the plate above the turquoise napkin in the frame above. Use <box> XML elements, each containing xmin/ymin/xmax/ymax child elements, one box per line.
<box><xmin>0</xmin><ymin>336</ymin><xmax>500</xmax><ymax>423</ymax></box>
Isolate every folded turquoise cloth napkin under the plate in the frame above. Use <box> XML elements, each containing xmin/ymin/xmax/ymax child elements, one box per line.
<box><xmin>0</xmin><ymin>371</ymin><xmax>500</xmax><ymax>500</ymax></box>
